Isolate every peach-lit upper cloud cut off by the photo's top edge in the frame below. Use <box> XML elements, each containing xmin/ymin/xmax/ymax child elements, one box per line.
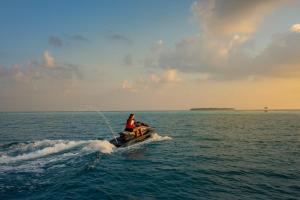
<box><xmin>192</xmin><ymin>0</ymin><xmax>289</xmax><ymax>36</ymax></box>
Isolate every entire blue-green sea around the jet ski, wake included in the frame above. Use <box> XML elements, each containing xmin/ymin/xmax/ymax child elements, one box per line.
<box><xmin>0</xmin><ymin>111</ymin><xmax>300</xmax><ymax>199</ymax></box>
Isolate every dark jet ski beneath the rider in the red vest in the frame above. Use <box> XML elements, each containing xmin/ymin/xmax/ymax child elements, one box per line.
<box><xmin>109</xmin><ymin>123</ymin><xmax>155</xmax><ymax>147</ymax></box>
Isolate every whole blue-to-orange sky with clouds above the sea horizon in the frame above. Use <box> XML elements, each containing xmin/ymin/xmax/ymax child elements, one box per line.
<box><xmin>0</xmin><ymin>0</ymin><xmax>300</xmax><ymax>111</ymax></box>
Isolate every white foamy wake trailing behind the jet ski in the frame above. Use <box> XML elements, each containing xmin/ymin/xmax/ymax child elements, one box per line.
<box><xmin>0</xmin><ymin>140</ymin><xmax>116</xmax><ymax>173</ymax></box>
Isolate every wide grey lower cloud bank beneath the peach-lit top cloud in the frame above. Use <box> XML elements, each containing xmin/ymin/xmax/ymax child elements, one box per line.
<box><xmin>148</xmin><ymin>29</ymin><xmax>300</xmax><ymax>80</ymax></box>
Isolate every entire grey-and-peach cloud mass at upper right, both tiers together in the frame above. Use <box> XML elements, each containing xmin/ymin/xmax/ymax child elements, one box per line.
<box><xmin>144</xmin><ymin>0</ymin><xmax>300</xmax><ymax>81</ymax></box>
